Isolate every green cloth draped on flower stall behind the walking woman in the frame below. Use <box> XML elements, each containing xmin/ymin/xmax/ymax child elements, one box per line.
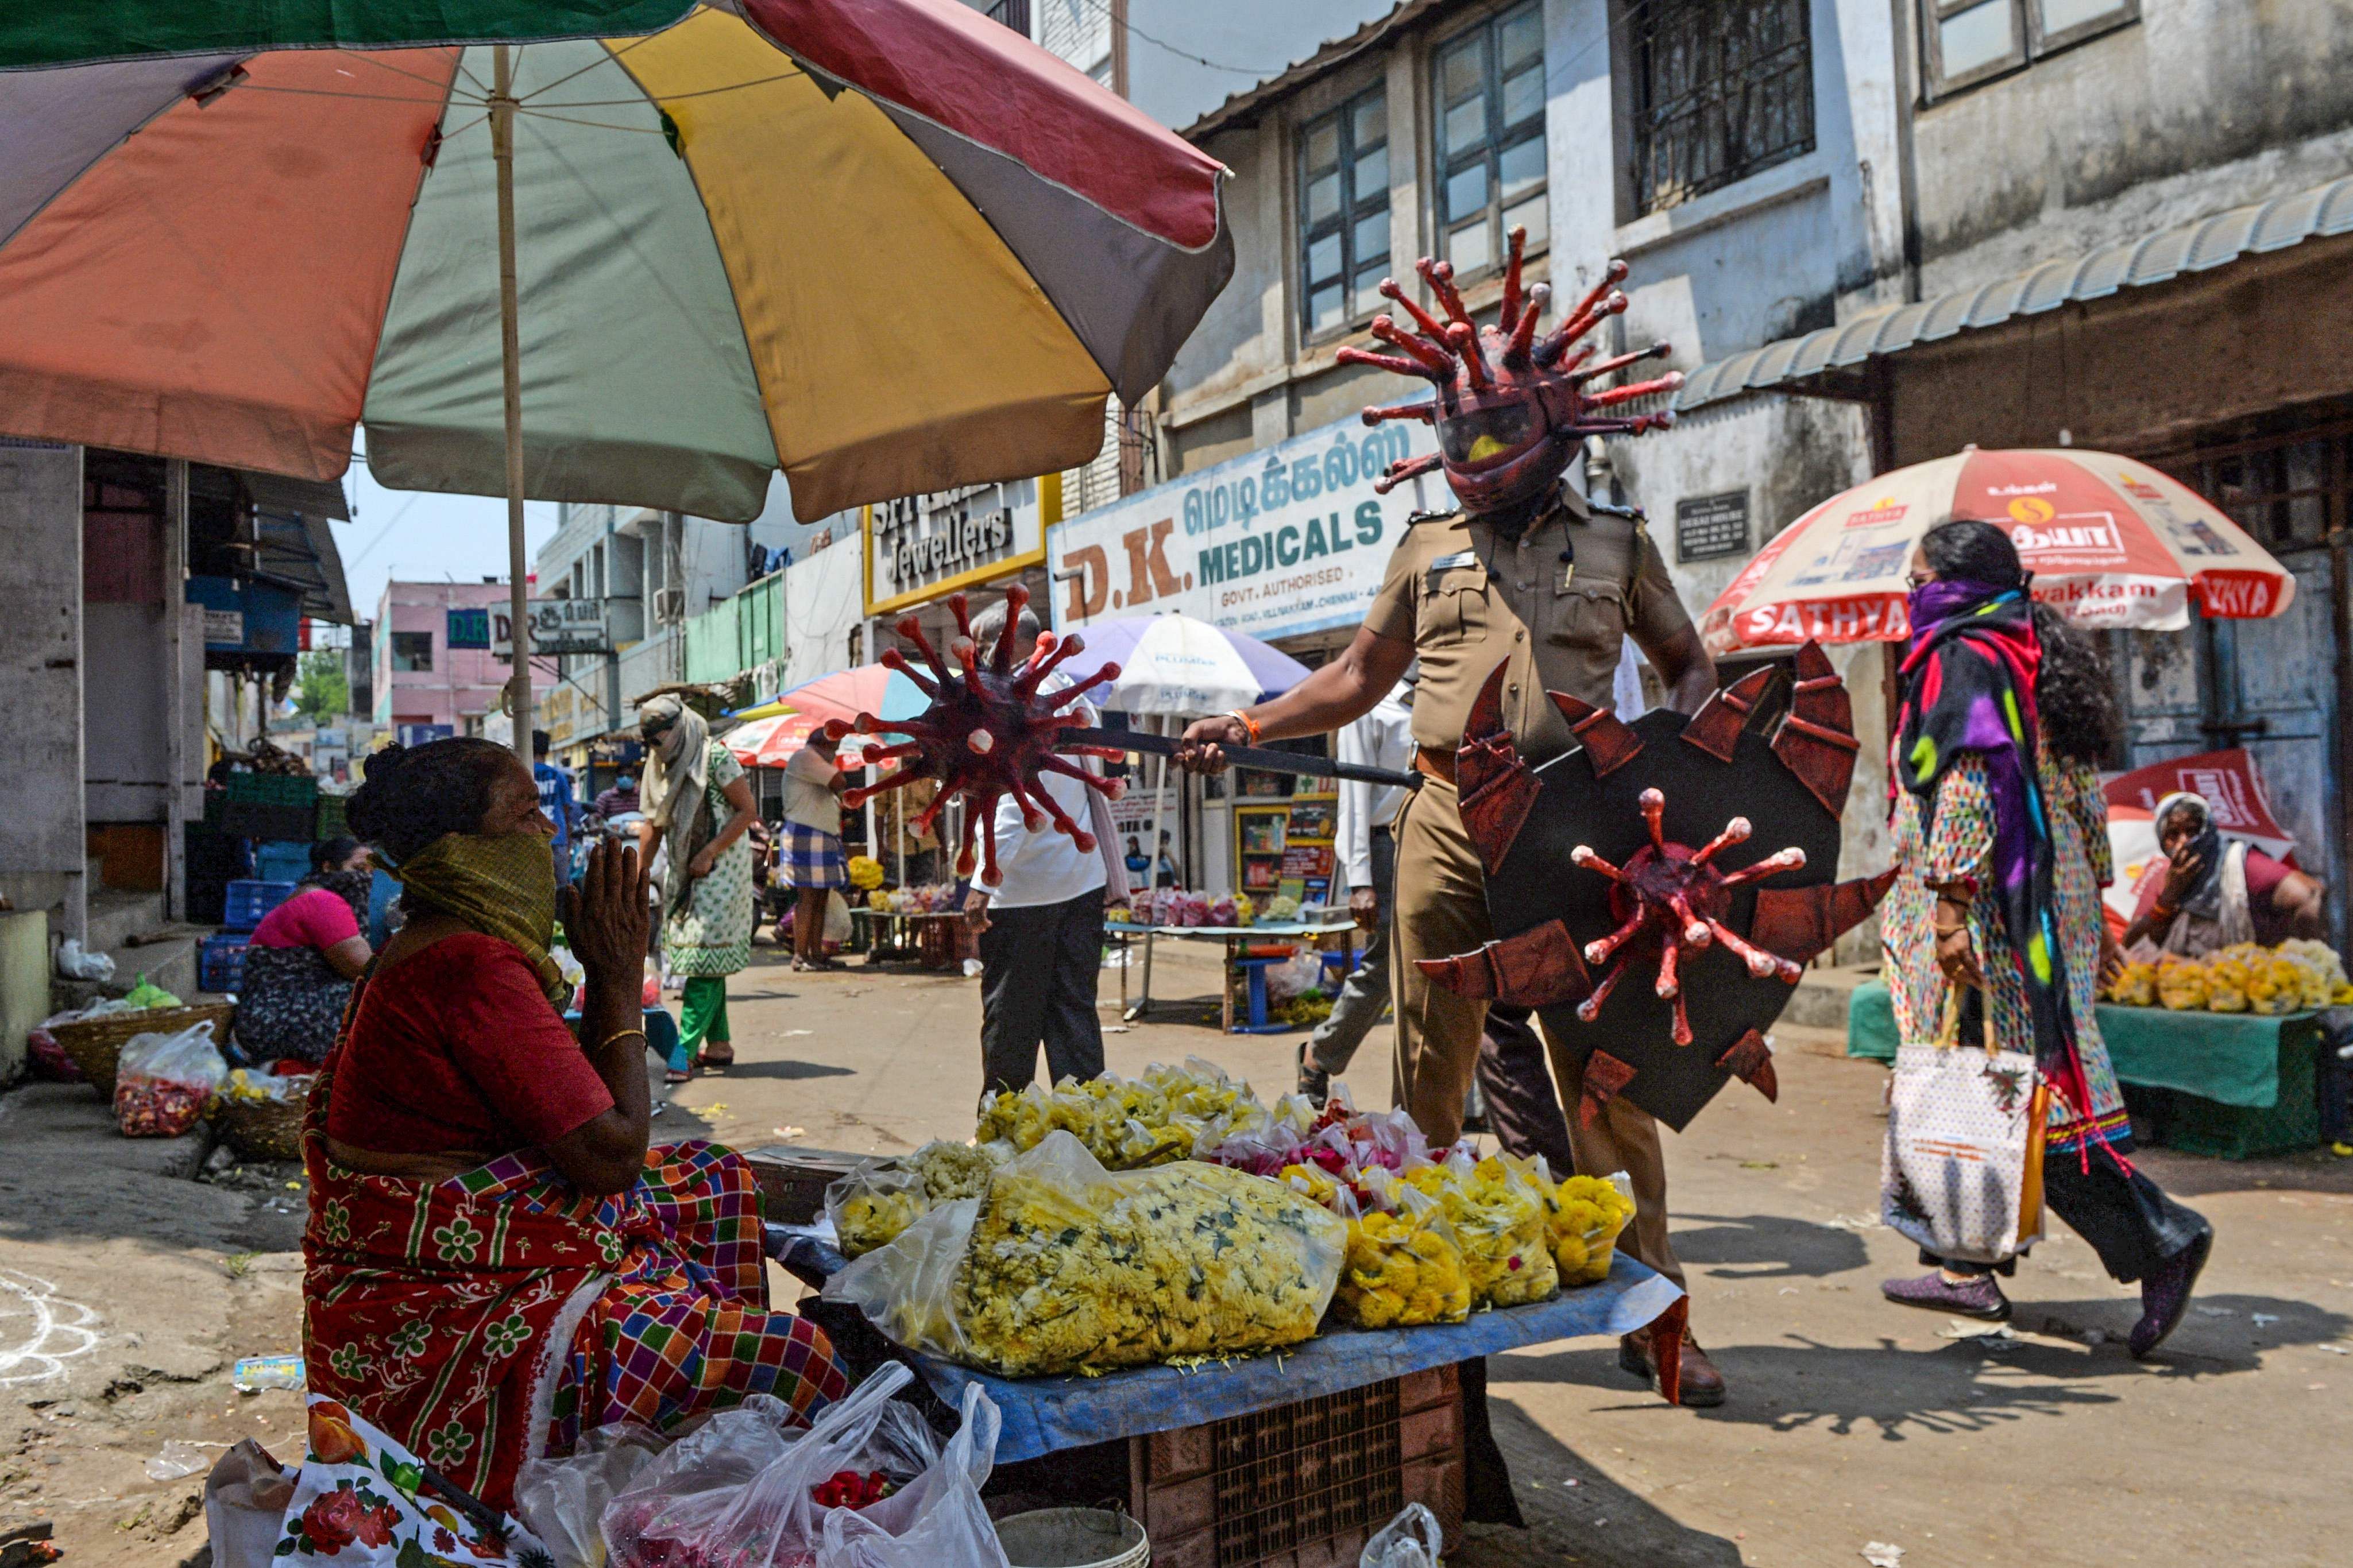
<box><xmin>1847</xmin><ymin>980</ymin><xmax>2323</xmax><ymax>1159</ymax></box>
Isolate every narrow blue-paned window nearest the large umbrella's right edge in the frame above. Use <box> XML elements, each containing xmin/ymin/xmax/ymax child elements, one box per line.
<box><xmin>1299</xmin><ymin>87</ymin><xmax>1388</xmax><ymax>336</ymax></box>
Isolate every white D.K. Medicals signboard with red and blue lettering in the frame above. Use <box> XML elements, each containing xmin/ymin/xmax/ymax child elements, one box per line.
<box><xmin>1047</xmin><ymin>419</ymin><xmax>1454</xmax><ymax>640</ymax></box>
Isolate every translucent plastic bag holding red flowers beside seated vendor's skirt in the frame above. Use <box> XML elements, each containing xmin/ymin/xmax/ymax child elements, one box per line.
<box><xmin>602</xmin><ymin>1364</ymin><xmax>1004</xmax><ymax>1568</ymax></box>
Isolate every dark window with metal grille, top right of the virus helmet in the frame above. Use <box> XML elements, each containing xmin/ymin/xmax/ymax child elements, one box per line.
<box><xmin>1628</xmin><ymin>0</ymin><xmax>1814</xmax><ymax>216</ymax></box>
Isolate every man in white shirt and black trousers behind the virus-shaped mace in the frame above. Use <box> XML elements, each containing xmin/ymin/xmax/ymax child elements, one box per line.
<box><xmin>965</xmin><ymin>602</ymin><xmax>1127</xmax><ymax>1093</ymax></box>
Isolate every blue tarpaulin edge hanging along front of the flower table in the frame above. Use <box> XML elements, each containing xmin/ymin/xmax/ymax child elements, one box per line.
<box><xmin>894</xmin><ymin>1253</ymin><xmax>1682</xmax><ymax>1465</ymax></box>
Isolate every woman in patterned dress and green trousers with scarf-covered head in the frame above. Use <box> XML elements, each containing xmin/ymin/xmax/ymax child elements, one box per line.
<box><xmin>637</xmin><ymin>694</ymin><xmax>758</xmax><ymax>1084</ymax></box>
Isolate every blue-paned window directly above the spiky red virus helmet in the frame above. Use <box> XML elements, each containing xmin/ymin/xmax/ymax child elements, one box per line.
<box><xmin>1431</xmin><ymin>2</ymin><xmax>1551</xmax><ymax>277</ymax></box>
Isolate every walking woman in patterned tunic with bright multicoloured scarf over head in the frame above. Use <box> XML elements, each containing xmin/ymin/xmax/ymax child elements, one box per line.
<box><xmin>1880</xmin><ymin>520</ymin><xmax>2214</xmax><ymax>1356</ymax></box>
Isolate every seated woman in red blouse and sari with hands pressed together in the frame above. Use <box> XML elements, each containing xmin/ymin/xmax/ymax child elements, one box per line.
<box><xmin>304</xmin><ymin>741</ymin><xmax>847</xmax><ymax>1507</ymax></box>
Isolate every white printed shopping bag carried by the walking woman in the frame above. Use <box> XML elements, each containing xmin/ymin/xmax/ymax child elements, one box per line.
<box><xmin>1880</xmin><ymin>988</ymin><xmax>2049</xmax><ymax>1263</ymax></box>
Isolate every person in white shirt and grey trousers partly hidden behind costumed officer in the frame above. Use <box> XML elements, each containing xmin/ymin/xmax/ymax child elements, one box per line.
<box><xmin>1299</xmin><ymin>665</ymin><xmax>1421</xmax><ymax>1105</ymax></box>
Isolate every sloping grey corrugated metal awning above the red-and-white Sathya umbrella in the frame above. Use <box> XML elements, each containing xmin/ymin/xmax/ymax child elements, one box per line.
<box><xmin>1675</xmin><ymin>174</ymin><xmax>2353</xmax><ymax>409</ymax></box>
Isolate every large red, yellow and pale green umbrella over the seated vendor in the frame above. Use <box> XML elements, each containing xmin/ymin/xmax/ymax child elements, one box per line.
<box><xmin>0</xmin><ymin>0</ymin><xmax>1233</xmax><ymax>745</ymax></box>
